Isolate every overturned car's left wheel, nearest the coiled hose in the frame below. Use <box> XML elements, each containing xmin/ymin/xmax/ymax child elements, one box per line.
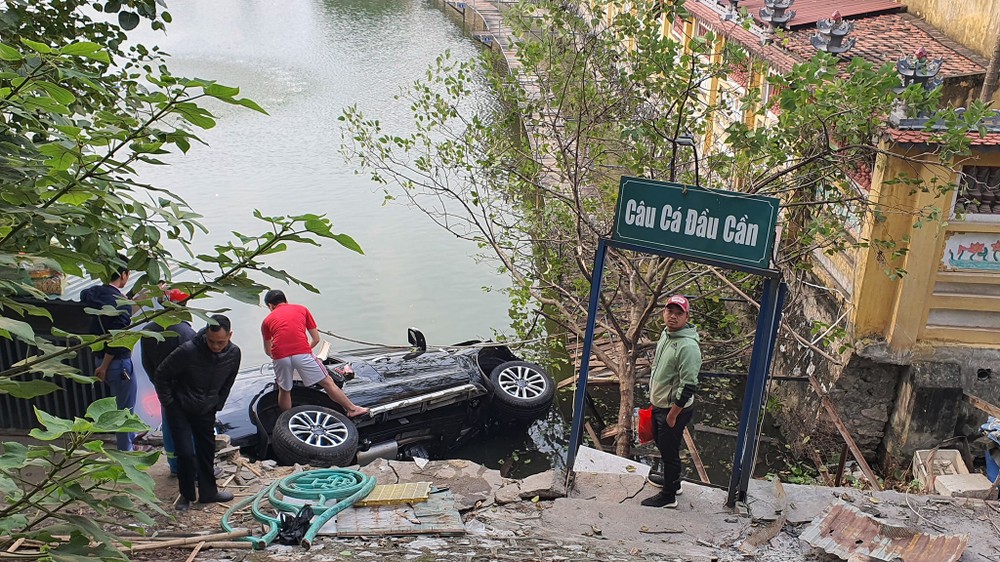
<box><xmin>271</xmin><ymin>406</ymin><xmax>358</xmax><ymax>467</ymax></box>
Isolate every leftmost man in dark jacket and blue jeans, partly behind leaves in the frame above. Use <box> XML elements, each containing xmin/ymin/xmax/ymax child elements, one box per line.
<box><xmin>80</xmin><ymin>256</ymin><xmax>136</xmax><ymax>451</ymax></box>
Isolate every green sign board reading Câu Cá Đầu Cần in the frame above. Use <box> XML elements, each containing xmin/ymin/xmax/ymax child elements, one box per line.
<box><xmin>611</xmin><ymin>176</ymin><xmax>779</xmax><ymax>269</ymax></box>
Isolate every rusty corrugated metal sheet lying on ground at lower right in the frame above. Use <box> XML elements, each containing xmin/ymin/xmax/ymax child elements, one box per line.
<box><xmin>800</xmin><ymin>502</ymin><xmax>969</xmax><ymax>562</ymax></box>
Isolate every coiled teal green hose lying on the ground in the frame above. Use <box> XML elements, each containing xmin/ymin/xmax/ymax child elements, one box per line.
<box><xmin>222</xmin><ymin>468</ymin><xmax>375</xmax><ymax>550</ymax></box>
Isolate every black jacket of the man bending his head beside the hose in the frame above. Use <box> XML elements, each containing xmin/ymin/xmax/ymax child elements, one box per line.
<box><xmin>153</xmin><ymin>328</ymin><xmax>240</xmax><ymax>416</ymax></box>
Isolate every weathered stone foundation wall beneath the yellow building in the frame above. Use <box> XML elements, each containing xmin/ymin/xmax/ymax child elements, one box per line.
<box><xmin>773</xmin><ymin>278</ymin><xmax>1000</xmax><ymax>467</ymax></box>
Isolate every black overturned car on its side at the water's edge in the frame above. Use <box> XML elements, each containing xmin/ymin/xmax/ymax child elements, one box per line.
<box><xmin>216</xmin><ymin>329</ymin><xmax>555</xmax><ymax>466</ymax></box>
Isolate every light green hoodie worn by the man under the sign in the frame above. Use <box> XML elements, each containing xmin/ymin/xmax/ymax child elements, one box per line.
<box><xmin>649</xmin><ymin>324</ymin><xmax>701</xmax><ymax>408</ymax></box>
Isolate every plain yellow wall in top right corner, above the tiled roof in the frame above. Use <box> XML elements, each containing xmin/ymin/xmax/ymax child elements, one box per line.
<box><xmin>905</xmin><ymin>0</ymin><xmax>1000</xmax><ymax>58</ymax></box>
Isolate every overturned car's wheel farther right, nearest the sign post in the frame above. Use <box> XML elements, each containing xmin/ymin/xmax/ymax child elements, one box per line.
<box><xmin>490</xmin><ymin>361</ymin><xmax>556</xmax><ymax>420</ymax></box>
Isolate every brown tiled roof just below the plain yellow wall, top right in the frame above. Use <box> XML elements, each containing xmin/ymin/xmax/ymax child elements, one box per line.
<box><xmin>787</xmin><ymin>12</ymin><xmax>988</xmax><ymax>78</ymax></box>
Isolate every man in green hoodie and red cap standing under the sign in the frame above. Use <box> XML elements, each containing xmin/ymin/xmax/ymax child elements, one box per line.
<box><xmin>642</xmin><ymin>295</ymin><xmax>701</xmax><ymax>507</ymax></box>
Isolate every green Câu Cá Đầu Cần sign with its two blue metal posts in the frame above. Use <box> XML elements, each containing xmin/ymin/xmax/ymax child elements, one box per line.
<box><xmin>566</xmin><ymin>177</ymin><xmax>787</xmax><ymax>507</ymax></box>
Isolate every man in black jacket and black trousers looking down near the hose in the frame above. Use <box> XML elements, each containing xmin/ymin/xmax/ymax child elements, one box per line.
<box><xmin>154</xmin><ymin>314</ymin><xmax>240</xmax><ymax>511</ymax></box>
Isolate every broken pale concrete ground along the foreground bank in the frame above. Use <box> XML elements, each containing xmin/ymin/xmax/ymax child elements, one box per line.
<box><xmin>123</xmin><ymin>450</ymin><xmax>1000</xmax><ymax>562</ymax></box>
